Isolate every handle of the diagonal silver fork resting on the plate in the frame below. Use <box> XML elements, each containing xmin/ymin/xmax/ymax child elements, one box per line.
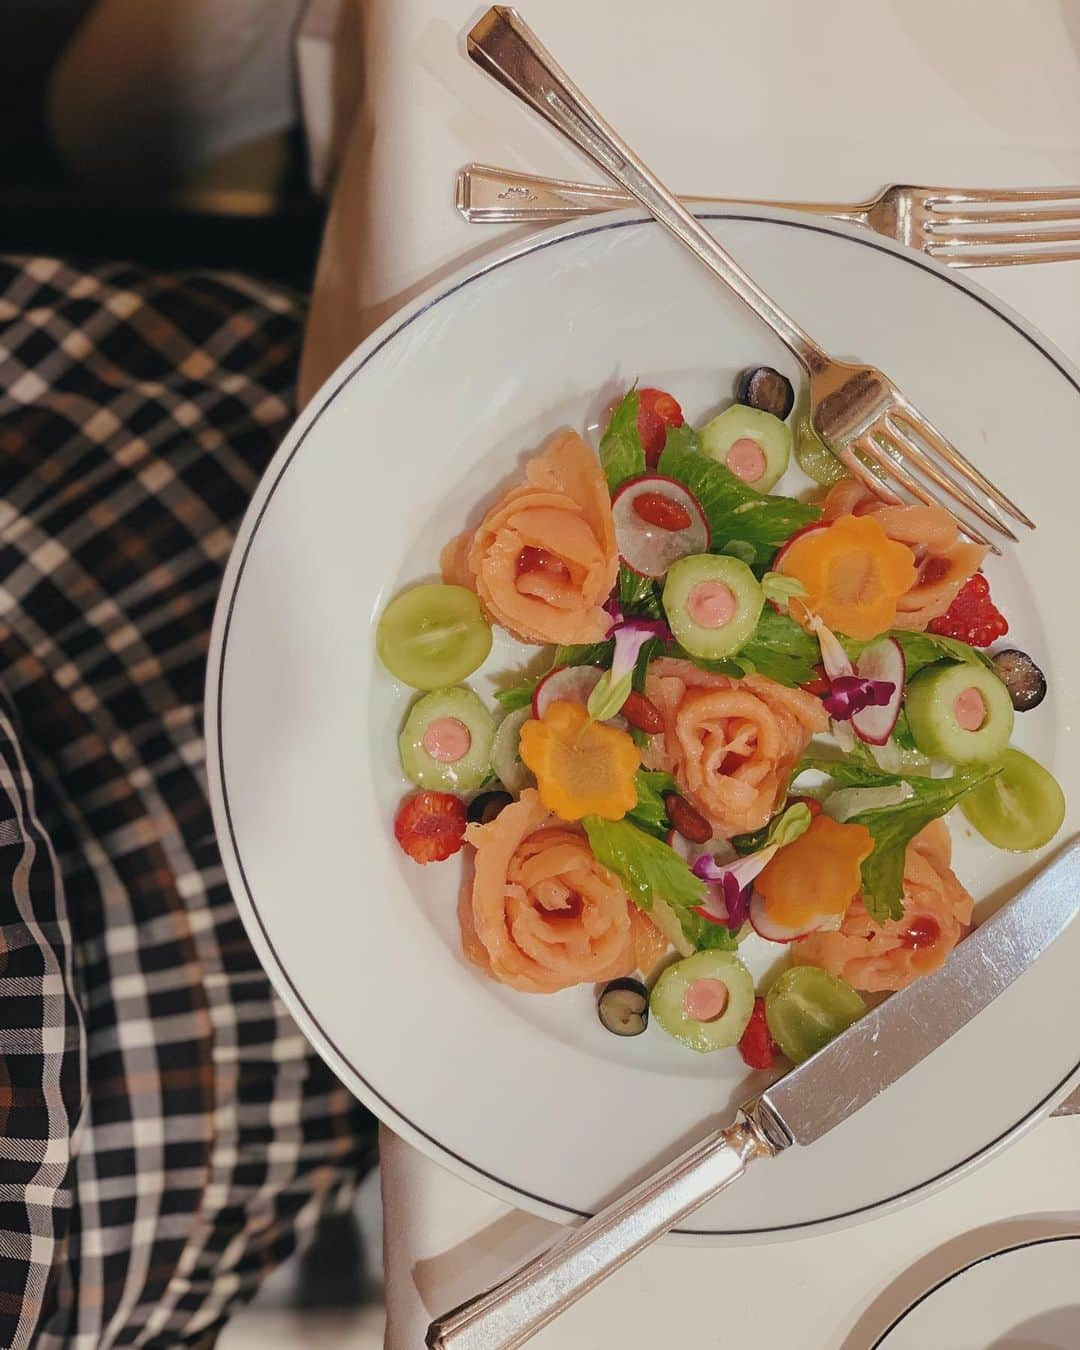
<box><xmin>467</xmin><ymin>5</ymin><xmax>829</xmax><ymax>375</ymax></box>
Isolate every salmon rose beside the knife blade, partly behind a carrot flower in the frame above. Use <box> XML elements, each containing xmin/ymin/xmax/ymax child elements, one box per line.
<box><xmin>791</xmin><ymin>821</ymin><xmax>975</xmax><ymax>994</ymax></box>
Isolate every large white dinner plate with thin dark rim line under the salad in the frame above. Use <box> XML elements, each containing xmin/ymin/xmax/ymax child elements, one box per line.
<box><xmin>207</xmin><ymin>211</ymin><xmax>1080</xmax><ymax>1239</ymax></box>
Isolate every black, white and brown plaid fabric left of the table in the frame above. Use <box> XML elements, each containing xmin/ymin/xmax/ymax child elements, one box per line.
<box><xmin>0</xmin><ymin>259</ymin><xmax>374</xmax><ymax>1350</ymax></box>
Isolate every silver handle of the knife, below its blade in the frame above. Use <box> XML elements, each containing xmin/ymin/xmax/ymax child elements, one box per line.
<box><xmin>425</xmin><ymin>1112</ymin><xmax>779</xmax><ymax>1350</ymax></box>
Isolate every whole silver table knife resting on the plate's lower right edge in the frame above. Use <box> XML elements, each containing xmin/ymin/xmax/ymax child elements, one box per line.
<box><xmin>427</xmin><ymin>842</ymin><xmax>1080</xmax><ymax>1350</ymax></box>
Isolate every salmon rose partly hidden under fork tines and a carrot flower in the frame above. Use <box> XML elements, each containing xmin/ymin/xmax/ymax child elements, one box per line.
<box><xmin>822</xmin><ymin>478</ymin><xmax>987</xmax><ymax>633</ymax></box>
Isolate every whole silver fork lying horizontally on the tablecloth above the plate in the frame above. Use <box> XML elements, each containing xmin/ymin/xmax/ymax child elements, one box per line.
<box><xmin>456</xmin><ymin>163</ymin><xmax>1080</xmax><ymax>267</ymax></box>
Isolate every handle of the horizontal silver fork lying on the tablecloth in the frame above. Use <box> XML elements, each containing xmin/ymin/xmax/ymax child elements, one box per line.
<box><xmin>456</xmin><ymin>163</ymin><xmax>868</xmax><ymax>225</ymax></box>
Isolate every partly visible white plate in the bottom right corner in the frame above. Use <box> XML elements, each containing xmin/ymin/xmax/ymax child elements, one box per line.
<box><xmin>871</xmin><ymin>1234</ymin><xmax>1080</xmax><ymax>1350</ymax></box>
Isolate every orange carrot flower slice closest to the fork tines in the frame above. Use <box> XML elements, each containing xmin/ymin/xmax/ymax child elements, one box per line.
<box><xmin>780</xmin><ymin>516</ymin><xmax>918</xmax><ymax>641</ymax></box>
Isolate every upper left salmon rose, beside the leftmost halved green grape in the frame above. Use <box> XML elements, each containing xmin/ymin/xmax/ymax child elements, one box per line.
<box><xmin>441</xmin><ymin>431</ymin><xmax>618</xmax><ymax>645</ymax></box>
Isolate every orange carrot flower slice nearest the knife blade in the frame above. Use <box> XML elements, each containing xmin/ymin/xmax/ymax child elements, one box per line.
<box><xmin>756</xmin><ymin>814</ymin><xmax>873</xmax><ymax>929</ymax></box>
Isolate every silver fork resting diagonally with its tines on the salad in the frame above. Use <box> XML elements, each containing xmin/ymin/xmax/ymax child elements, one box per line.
<box><xmin>467</xmin><ymin>5</ymin><xmax>1034</xmax><ymax>552</ymax></box>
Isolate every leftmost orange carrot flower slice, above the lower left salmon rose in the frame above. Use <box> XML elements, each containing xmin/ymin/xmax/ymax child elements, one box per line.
<box><xmin>518</xmin><ymin>699</ymin><xmax>641</xmax><ymax>821</ymax></box>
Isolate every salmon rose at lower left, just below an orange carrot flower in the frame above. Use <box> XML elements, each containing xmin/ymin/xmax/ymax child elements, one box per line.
<box><xmin>458</xmin><ymin>788</ymin><xmax>640</xmax><ymax>994</ymax></box>
